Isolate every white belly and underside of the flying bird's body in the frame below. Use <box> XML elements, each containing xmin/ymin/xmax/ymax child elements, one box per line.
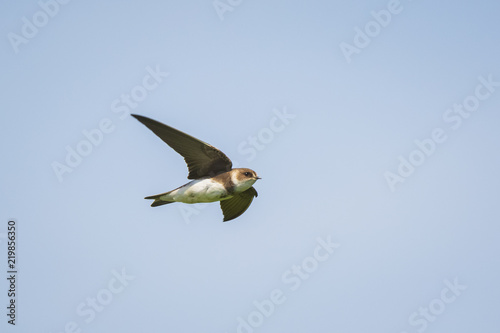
<box><xmin>160</xmin><ymin>178</ymin><xmax>230</xmax><ymax>203</ymax></box>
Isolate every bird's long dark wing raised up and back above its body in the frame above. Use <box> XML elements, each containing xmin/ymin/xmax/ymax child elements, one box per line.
<box><xmin>132</xmin><ymin>114</ymin><xmax>233</xmax><ymax>179</ymax></box>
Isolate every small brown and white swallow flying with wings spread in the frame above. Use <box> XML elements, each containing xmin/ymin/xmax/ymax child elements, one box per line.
<box><xmin>131</xmin><ymin>114</ymin><xmax>262</xmax><ymax>222</ymax></box>
